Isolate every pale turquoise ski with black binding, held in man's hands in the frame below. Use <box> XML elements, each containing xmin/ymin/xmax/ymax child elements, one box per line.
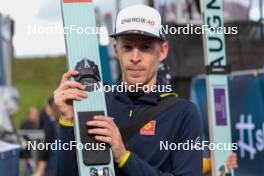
<box><xmin>61</xmin><ymin>0</ymin><xmax>115</xmax><ymax>176</ymax></box>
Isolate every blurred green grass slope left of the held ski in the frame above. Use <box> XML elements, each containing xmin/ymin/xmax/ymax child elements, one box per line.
<box><xmin>12</xmin><ymin>57</ymin><xmax>67</xmax><ymax>127</ymax></box>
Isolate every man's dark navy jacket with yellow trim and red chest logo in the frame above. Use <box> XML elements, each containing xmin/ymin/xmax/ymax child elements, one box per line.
<box><xmin>58</xmin><ymin>80</ymin><xmax>202</xmax><ymax>176</ymax></box>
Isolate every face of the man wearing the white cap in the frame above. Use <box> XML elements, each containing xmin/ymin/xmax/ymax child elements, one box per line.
<box><xmin>115</xmin><ymin>35</ymin><xmax>168</xmax><ymax>84</ymax></box>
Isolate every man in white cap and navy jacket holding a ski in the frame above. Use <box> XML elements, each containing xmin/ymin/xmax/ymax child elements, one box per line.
<box><xmin>54</xmin><ymin>5</ymin><xmax>202</xmax><ymax>176</ymax></box>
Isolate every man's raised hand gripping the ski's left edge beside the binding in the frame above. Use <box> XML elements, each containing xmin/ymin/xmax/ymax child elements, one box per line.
<box><xmin>54</xmin><ymin>70</ymin><xmax>87</xmax><ymax>122</ymax></box>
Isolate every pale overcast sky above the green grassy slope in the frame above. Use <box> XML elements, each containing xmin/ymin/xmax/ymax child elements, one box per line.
<box><xmin>0</xmin><ymin>0</ymin><xmax>258</xmax><ymax>57</ymax></box>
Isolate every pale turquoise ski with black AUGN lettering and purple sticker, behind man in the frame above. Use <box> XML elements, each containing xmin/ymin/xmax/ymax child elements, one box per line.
<box><xmin>200</xmin><ymin>0</ymin><xmax>233</xmax><ymax>176</ymax></box>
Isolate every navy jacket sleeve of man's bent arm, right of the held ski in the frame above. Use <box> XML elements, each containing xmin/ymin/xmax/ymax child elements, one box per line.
<box><xmin>121</xmin><ymin>104</ymin><xmax>202</xmax><ymax>176</ymax></box>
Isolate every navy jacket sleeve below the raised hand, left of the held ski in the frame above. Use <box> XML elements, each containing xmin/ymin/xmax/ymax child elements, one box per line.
<box><xmin>58</xmin><ymin>125</ymin><xmax>78</xmax><ymax>176</ymax></box>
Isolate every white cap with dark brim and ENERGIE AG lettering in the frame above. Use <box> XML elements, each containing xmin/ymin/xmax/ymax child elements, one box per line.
<box><xmin>110</xmin><ymin>4</ymin><xmax>165</xmax><ymax>40</ymax></box>
